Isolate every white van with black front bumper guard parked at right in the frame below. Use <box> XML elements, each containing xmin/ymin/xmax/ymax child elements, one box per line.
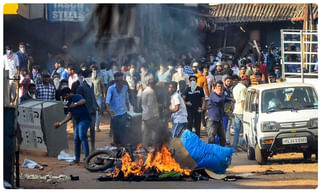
<box><xmin>243</xmin><ymin>83</ymin><xmax>318</xmax><ymax>164</ymax></box>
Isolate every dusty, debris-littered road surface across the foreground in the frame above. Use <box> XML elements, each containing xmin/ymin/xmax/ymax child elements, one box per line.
<box><xmin>20</xmin><ymin>120</ymin><xmax>318</xmax><ymax>189</ymax></box>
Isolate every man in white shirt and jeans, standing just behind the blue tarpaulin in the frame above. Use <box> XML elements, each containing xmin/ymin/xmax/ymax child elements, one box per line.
<box><xmin>168</xmin><ymin>81</ymin><xmax>188</xmax><ymax>137</ymax></box>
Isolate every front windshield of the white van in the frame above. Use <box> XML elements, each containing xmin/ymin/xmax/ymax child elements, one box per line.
<box><xmin>261</xmin><ymin>87</ymin><xmax>318</xmax><ymax>113</ymax></box>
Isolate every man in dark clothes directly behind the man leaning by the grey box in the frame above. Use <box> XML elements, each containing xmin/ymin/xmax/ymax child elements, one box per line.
<box><xmin>77</xmin><ymin>70</ymin><xmax>99</xmax><ymax>151</ymax></box>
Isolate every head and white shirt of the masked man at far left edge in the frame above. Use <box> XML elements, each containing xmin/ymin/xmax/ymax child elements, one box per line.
<box><xmin>3</xmin><ymin>46</ymin><xmax>19</xmax><ymax>81</ymax></box>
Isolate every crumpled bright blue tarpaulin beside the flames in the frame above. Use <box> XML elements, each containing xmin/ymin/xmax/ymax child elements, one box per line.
<box><xmin>180</xmin><ymin>130</ymin><xmax>235</xmax><ymax>174</ymax></box>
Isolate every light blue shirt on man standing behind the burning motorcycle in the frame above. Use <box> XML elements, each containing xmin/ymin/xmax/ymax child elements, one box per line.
<box><xmin>106</xmin><ymin>83</ymin><xmax>129</xmax><ymax>116</ymax></box>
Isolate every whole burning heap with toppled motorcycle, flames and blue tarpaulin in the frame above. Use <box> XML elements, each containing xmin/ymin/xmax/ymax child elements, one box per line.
<box><xmin>85</xmin><ymin>131</ymin><xmax>234</xmax><ymax>181</ymax></box>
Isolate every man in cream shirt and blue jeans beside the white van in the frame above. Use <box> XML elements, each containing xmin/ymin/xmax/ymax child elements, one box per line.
<box><xmin>232</xmin><ymin>75</ymin><xmax>249</xmax><ymax>149</ymax></box>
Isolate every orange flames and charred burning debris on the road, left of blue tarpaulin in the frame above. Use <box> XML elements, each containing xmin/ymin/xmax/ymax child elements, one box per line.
<box><xmin>92</xmin><ymin>144</ymin><xmax>191</xmax><ymax>181</ymax></box>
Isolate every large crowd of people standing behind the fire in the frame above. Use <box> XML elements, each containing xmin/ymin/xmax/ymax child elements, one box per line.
<box><xmin>4</xmin><ymin>43</ymin><xmax>281</xmax><ymax>161</ymax></box>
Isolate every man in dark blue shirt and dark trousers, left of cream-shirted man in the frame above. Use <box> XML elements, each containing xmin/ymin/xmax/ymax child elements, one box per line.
<box><xmin>206</xmin><ymin>80</ymin><xmax>226</xmax><ymax>146</ymax></box>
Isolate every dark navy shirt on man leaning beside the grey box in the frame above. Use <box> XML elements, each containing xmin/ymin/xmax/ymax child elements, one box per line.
<box><xmin>67</xmin><ymin>94</ymin><xmax>91</xmax><ymax>123</ymax></box>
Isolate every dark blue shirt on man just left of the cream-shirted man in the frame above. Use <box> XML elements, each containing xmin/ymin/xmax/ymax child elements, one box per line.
<box><xmin>208</xmin><ymin>92</ymin><xmax>225</xmax><ymax>121</ymax></box>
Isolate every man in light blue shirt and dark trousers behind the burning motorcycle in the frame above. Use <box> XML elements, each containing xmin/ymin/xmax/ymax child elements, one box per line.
<box><xmin>106</xmin><ymin>72</ymin><xmax>130</xmax><ymax>145</ymax></box>
